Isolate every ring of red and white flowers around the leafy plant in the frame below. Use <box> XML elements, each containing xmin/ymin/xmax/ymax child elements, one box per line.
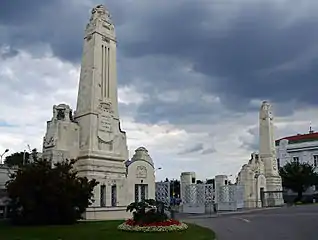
<box><xmin>118</xmin><ymin>219</ymin><xmax>188</xmax><ymax>232</ymax></box>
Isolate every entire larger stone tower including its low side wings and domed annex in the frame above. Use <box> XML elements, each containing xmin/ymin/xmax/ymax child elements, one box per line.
<box><xmin>42</xmin><ymin>5</ymin><xmax>155</xmax><ymax>220</ymax></box>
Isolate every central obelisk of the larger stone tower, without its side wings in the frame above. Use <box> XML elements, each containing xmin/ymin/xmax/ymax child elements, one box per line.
<box><xmin>74</xmin><ymin>5</ymin><xmax>128</xmax><ymax>207</ymax></box>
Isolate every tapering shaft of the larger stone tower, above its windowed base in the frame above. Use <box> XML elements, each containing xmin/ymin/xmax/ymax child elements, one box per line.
<box><xmin>75</xmin><ymin>5</ymin><xmax>128</xmax><ymax>162</ymax></box>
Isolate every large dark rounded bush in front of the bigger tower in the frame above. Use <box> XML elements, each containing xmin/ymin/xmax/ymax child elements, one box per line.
<box><xmin>6</xmin><ymin>159</ymin><xmax>98</xmax><ymax>225</ymax></box>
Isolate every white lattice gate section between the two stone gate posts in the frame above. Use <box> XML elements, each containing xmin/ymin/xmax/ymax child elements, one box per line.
<box><xmin>181</xmin><ymin>184</ymin><xmax>214</xmax><ymax>214</ymax></box>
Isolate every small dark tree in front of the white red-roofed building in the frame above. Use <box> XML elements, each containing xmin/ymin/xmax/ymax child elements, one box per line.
<box><xmin>279</xmin><ymin>161</ymin><xmax>317</xmax><ymax>201</ymax></box>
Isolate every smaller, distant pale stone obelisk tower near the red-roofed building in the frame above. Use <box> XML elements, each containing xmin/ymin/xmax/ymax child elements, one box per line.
<box><xmin>259</xmin><ymin>101</ymin><xmax>283</xmax><ymax>206</ymax></box>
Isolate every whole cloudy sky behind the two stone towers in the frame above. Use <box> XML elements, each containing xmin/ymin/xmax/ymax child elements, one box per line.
<box><xmin>0</xmin><ymin>0</ymin><xmax>318</xmax><ymax>180</ymax></box>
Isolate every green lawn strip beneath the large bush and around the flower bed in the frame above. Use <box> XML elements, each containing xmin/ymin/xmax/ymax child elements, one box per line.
<box><xmin>0</xmin><ymin>221</ymin><xmax>214</xmax><ymax>240</ymax></box>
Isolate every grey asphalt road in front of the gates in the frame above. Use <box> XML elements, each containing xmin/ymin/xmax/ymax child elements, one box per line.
<box><xmin>180</xmin><ymin>205</ymin><xmax>318</xmax><ymax>240</ymax></box>
